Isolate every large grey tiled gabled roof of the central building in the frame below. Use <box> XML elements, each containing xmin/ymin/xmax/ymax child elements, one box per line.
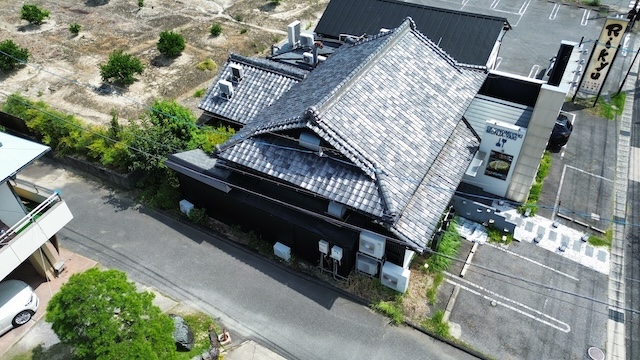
<box><xmin>169</xmin><ymin>18</ymin><xmax>487</xmax><ymax>252</ymax></box>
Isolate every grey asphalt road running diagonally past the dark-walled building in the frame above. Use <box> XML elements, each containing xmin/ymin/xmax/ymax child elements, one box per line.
<box><xmin>20</xmin><ymin>160</ymin><xmax>473</xmax><ymax>360</ymax></box>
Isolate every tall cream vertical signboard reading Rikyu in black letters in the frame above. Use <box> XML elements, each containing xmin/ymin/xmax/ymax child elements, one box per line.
<box><xmin>579</xmin><ymin>18</ymin><xmax>629</xmax><ymax>95</ymax></box>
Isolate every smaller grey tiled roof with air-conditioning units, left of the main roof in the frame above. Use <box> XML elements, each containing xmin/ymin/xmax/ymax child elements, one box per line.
<box><xmin>199</xmin><ymin>54</ymin><xmax>308</xmax><ymax>125</ymax></box>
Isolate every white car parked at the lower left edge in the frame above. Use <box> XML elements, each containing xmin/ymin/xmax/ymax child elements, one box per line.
<box><xmin>0</xmin><ymin>280</ymin><xmax>40</xmax><ymax>335</ymax></box>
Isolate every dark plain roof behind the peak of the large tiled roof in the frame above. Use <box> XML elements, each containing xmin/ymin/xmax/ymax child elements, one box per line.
<box><xmin>315</xmin><ymin>0</ymin><xmax>509</xmax><ymax>65</ymax></box>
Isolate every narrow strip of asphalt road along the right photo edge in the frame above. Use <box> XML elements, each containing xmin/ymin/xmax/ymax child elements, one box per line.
<box><xmin>624</xmin><ymin>75</ymin><xmax>640</xmax><ymax>359</ymax></box>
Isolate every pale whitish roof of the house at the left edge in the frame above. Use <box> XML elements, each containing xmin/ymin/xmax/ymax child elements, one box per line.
<box><xmin>0</xmin><ymin>132</ymin><xmax>51</xmax><ymax>184</ymax></box>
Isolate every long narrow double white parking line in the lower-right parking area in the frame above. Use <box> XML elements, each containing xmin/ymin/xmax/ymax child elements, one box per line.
<box><xmin>445</xmin><ymin>273</ymin><xmax>571</xmax><ymax>333</ymax></box>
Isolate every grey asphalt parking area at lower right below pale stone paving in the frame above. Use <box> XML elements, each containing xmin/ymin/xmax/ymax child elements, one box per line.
<box><xmin>447</xmin><ymin>242</ymin><xmax>608</xmax><ymax>359</ymax></box>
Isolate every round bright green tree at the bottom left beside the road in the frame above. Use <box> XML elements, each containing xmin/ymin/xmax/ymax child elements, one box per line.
<box><xmin>46</xmin><ymin>268</ymin><xmax>176</xmax><ymax>360</ymax></box>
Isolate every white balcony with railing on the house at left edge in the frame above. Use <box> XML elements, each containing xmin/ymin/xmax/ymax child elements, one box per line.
<box><xmin>0</xmin><ymin>180</ymin><xmax>73</xmax><ymax>280</ymax></box>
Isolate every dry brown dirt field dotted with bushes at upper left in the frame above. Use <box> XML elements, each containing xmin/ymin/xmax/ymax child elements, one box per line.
<box><xmin>0</xmin><ymin>0</ymin><xmax>328</xmax><ymax>123</ymax></box>
